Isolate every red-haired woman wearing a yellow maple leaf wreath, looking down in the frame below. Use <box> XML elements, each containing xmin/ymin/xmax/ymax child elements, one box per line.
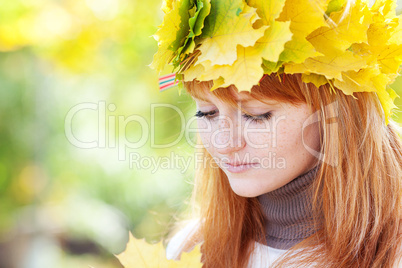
<box><xmin>153</xmin><ymin>0</ymin><xmax>402</xmax><ymax>267</ymax></box>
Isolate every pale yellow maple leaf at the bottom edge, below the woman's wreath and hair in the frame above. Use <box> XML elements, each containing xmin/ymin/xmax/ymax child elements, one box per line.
<box><xmin>116</xmin><ymin>233</ymin><xmax>202</xmax><ymax>268</ymax></box>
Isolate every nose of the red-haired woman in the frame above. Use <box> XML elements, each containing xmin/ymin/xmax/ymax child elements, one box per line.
<box><xmin>211</xmin><ymin>115</ymin><xmax>246</xmax><ymax>155</ymax></box>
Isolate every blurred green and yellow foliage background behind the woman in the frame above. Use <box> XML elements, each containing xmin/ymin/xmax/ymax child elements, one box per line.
<box><xmin>0</xmin><ymin>0</ymin><xmax>402</xmax><ymax>268</ymax></box>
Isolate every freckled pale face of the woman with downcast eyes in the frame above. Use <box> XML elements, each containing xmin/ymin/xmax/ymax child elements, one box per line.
<box><xmin>194</xmin><ymin>88</ymin><xmax>320</xmax><ymax>197</ymax></box>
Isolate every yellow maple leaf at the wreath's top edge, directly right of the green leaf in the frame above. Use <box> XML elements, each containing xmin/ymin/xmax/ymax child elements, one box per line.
<box><xmin>198</xmin><ymin>0</ymin><xmax>267</xmax><ymax>65</ymax></box>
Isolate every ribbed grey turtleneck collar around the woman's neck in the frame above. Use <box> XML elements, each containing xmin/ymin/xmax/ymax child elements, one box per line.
<box><xmin>258</xmin><ymin>165</ymin><xmax>320</xmax><ymax>249</ymax></box>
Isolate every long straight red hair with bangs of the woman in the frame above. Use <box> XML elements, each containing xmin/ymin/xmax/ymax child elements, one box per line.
<box><xmin>185</xmin><ymin>74</ymin><xmax>402</xmax><ymax>268</ymax></box>
